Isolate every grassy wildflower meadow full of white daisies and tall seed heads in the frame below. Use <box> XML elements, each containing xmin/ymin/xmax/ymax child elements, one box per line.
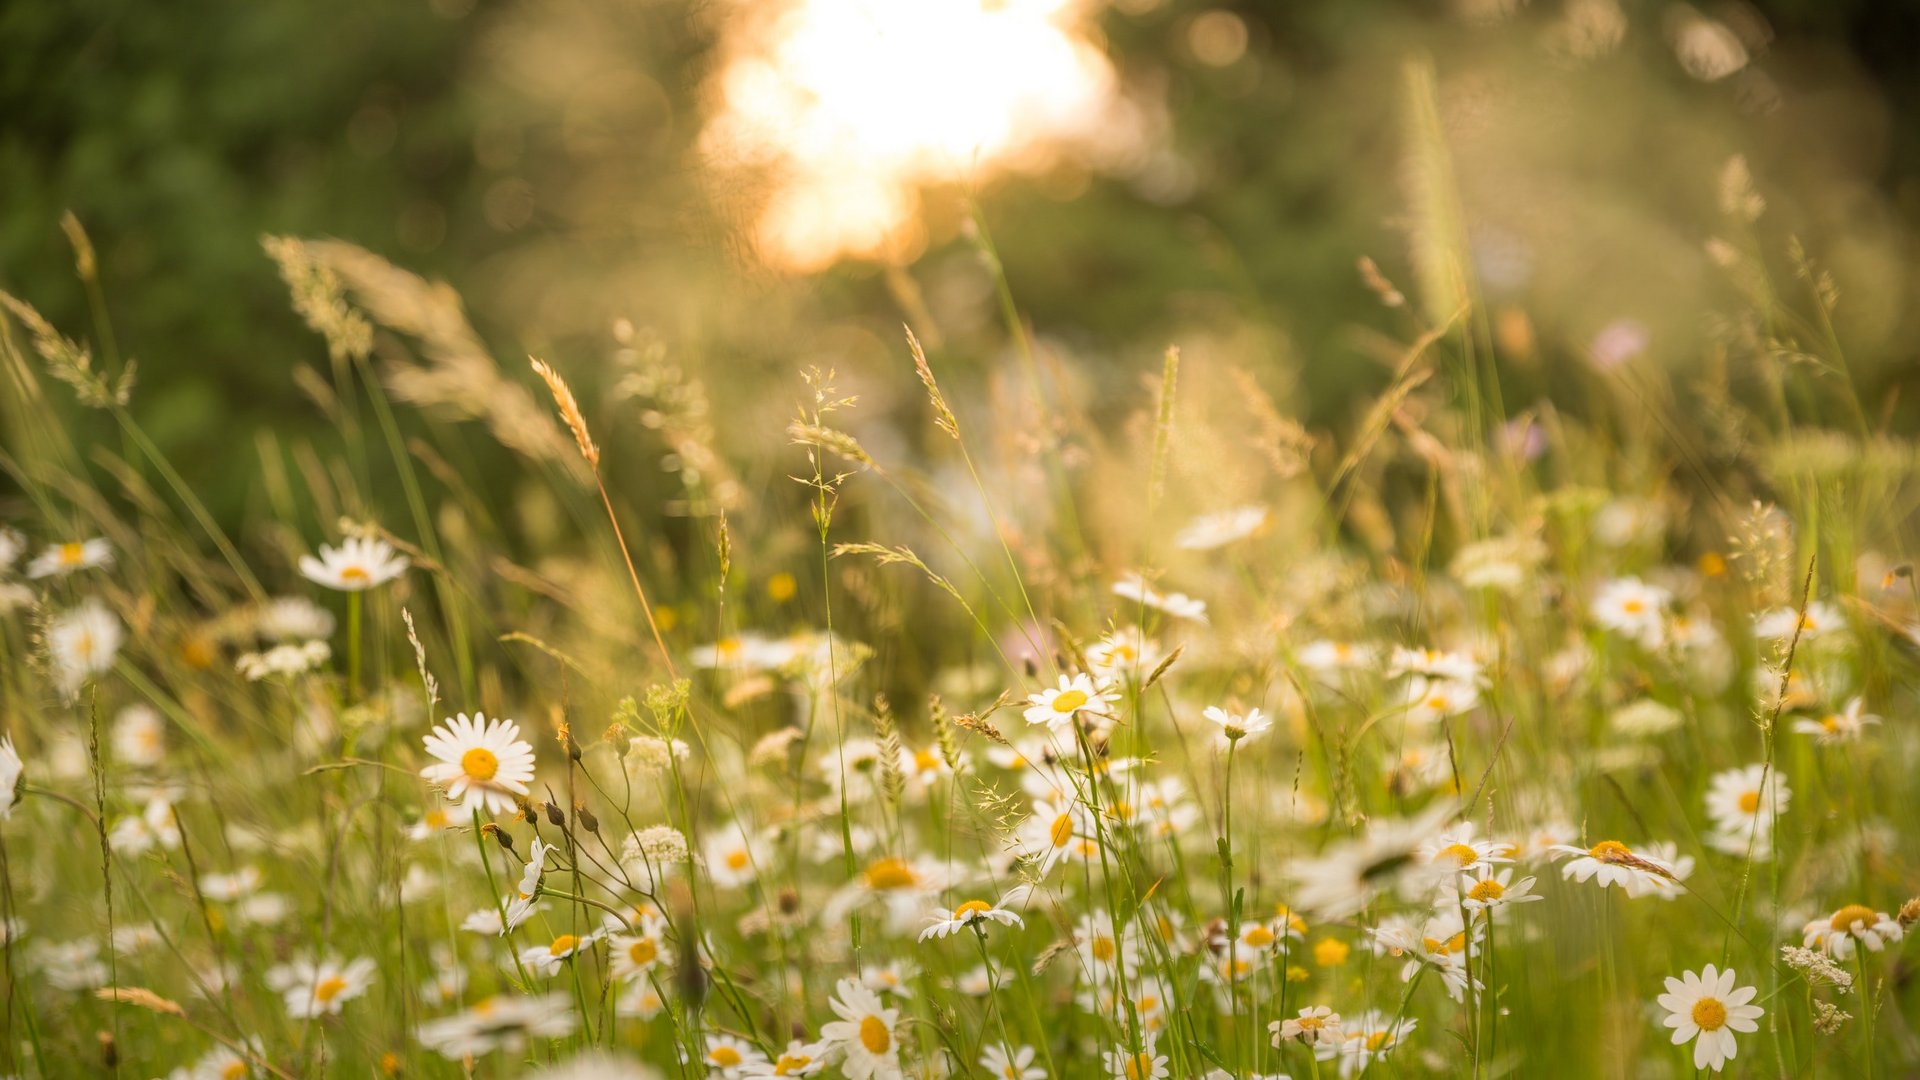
<box><xmin>0</xmin><ymin>46</ymin><xmax>1920</xmax><ymax>1080</ymax></box>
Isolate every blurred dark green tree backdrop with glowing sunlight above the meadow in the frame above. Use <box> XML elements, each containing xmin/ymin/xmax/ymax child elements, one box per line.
<box><xmin>0</xmin><ymin>0</ymin><xmax>1920</xmax><ymax>519</ymax></box>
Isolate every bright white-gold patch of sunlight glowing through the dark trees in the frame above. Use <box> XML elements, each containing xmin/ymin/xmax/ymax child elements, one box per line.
<box><xmin>705</xmin><ymin>0</ymin><xmax>1140</xmax><ymax>271</ymax></box>
